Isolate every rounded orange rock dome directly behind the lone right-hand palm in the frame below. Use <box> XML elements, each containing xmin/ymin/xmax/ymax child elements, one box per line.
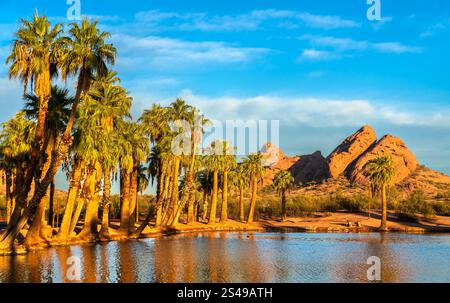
<box><xmin>348</xmin><ymin>135</ymin><xmax>419</xmax><ymax>184</ymax></box>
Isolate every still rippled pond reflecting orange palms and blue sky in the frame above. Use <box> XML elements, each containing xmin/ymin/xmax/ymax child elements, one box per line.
<box><xmin>0</xmin><ymin>233</ymin><xmax>450</xmax><ymax>283</ymax></box>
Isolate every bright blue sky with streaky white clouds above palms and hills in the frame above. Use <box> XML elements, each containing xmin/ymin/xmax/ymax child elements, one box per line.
<box><xmin>0</xmin><ymin>0</ymin><xmax>450</xmax><ymax>190</ymax></box>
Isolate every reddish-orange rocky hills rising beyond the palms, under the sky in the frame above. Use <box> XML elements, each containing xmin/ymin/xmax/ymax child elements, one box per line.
<box><xmin>264</xmin><ymin>125</ymin><xmax>450</xmax><ymax>200</ymax></box>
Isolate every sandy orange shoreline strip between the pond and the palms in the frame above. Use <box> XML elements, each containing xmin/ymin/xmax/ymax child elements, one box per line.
<box><xmin>0</xmin><ymin>212</ymin><xmax>450</xmax><ymax>256</ymax></box>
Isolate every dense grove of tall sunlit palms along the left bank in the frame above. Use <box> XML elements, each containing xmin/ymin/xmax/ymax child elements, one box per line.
<box><xmin>0</xmin><ymin>13</ymin><xmax>274</xmax><ymax>254</ymax></box>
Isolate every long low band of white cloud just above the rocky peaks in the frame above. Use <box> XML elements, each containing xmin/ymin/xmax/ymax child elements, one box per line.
<box><xmin>164</xmin><ymin>90</ymin><xmax>450</xmax><ymax>128</ymax></box>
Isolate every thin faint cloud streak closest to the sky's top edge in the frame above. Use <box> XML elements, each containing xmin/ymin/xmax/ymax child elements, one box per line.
<box><xmin>135</xmin><ymin>9</ymin><xmax>360</xmax><ymax>31</ymax></box>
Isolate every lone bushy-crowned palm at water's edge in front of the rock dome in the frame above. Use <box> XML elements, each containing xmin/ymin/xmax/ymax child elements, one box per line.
<box><xmin>366</xmin><ymin>156</ymin><xmax>395</xmax><ymax>231</ymax></box>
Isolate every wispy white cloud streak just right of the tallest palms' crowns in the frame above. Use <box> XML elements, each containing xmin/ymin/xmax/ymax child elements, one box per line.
<box><xmin>113</xmin><ymin>34</ymin><xmax>270</xmax><ymax>69</ymax></box>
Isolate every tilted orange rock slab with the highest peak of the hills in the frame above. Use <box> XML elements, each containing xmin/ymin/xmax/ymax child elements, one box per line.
<box><xmin>327</xmin><ymin>125</ymin><xmax>377</xmax><ymax>178</ymax></box>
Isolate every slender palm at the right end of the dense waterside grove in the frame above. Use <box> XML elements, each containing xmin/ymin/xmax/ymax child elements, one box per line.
<box><xmin>242</xmin><ymin>153</ymin><xmax>264</xmax><ymax>224</ymax></box>
